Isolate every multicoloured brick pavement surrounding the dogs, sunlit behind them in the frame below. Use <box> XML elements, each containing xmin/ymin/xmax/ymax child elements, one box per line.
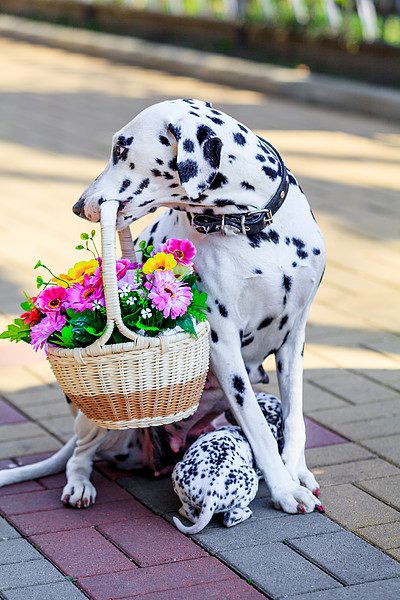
<box><xmin>0</xmin><ymin>27</ymin><xmax>400</xmax><ymax>600</ymax></box>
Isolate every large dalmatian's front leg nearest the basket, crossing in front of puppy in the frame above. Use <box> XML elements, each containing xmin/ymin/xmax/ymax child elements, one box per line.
<box><xmin>211</xmin><ymin>340</ymin><xmax>320</xmax><ymax>513</ymax></box>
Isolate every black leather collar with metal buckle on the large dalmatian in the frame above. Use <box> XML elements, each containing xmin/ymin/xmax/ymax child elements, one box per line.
<box><xmin>190</xmin><ymin>138</ymin><xmax>289</xmax><ymax>235</ymax></box>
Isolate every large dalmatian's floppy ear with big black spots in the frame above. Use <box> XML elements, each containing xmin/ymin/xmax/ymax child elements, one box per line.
<box><xmin>168</xmin><ymin>120</ymin><xmax>222</xmax><ymax>199</ymax></box>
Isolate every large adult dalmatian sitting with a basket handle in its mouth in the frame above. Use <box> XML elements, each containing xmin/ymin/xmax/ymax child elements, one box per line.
<box><xmin>0</xmin><ymin>99</ymin><xmax>325</xmax><ymax>513</ymax></box>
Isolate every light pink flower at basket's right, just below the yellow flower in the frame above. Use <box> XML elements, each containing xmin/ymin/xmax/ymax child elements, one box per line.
<box><xmin>145</xmin><ymin>271</ymin><xmax>193</xmax><ymax>319</ymax></box>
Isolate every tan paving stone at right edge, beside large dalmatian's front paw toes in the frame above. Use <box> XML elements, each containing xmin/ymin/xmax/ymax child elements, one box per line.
<box><xmin>313</xmin><ymin>458</ymin><xmax>399</xmax><ymax>487</ymax></box>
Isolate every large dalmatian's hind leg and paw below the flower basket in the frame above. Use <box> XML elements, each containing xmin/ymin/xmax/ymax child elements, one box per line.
<box><xmin>61</xmin><ymin>412</ymin><xmax>110</xmax><ymax>508</ymax></box>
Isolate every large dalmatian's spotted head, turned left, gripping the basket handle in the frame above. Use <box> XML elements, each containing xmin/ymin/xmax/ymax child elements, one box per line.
<box><xmin>73</xmin><ymin>100</ymin><xmax>223</xmax><ymax>229</ymax></box>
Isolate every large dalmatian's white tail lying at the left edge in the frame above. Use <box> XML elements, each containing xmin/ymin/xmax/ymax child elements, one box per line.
<box><xmin>0</xmin><ymin>435</ymin><xmax>77</xmax><ymax>487</ymax></box>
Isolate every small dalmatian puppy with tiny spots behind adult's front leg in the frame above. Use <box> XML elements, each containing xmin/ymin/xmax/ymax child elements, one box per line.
<box><xmin>172</xmin><ymin>393</ymin><xmax>283</xmax><ymax>534</ymax></box>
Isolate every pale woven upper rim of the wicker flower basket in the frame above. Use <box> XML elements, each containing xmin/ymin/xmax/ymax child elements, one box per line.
<box><xmin>47</xmin><ymin>321</ymin><xmax>210</xmax><ymax>361</ymax></box>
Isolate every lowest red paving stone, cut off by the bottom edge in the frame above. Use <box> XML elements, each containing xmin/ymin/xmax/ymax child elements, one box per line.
<box><xmin>130</xmin><ymin>577</ymin><xmax>265</xmax><ymax>600</ymax></box>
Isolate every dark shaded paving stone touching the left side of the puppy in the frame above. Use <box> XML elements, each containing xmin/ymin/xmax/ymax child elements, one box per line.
<box><xmin>118</xmin><ymin>474</ymin><xmax>181</xmax><ymax>515</ymax></box>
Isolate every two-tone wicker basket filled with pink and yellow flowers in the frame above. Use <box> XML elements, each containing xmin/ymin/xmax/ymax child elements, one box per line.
<box><xmin>0</xmin><ymin>202</ymin><xmax>209</xmax><ymax>429</ymax></box>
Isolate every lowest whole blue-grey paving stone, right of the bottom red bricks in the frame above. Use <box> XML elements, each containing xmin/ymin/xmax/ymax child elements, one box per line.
<box><xmin>218</xmin><ymin>543</ymin><xmax>340</xmax><ymax>600</ymax></box>
